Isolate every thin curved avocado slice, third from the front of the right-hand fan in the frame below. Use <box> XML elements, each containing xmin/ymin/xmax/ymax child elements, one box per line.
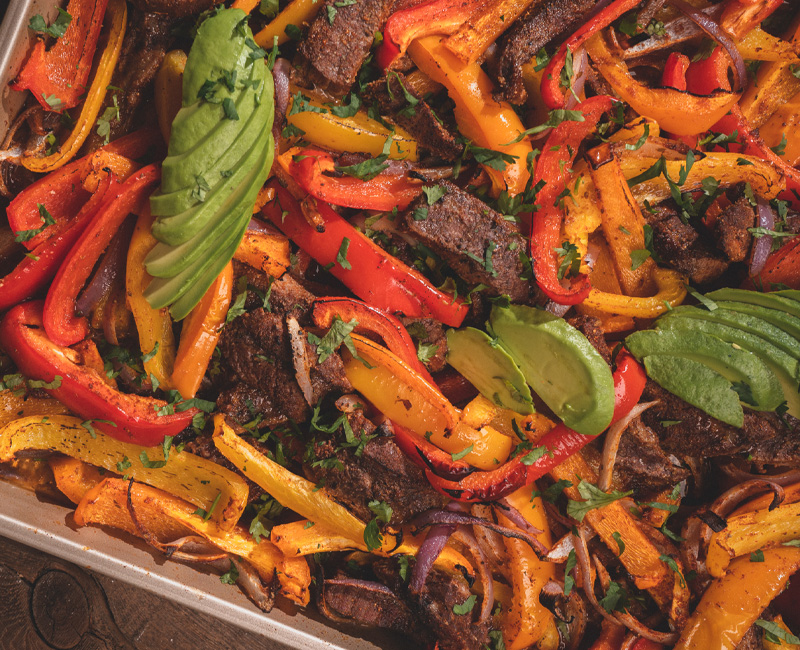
<box><xmin>657</xmin><ymin>318</ymin><xmax>800</xmax><ymax>417</ymax></box>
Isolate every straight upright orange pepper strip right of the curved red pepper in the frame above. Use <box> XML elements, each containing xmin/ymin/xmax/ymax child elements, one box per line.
<box><xmin>589</xmin><ymin>145</ymin><xmax>655</xmax><ymax>296</ymax></box>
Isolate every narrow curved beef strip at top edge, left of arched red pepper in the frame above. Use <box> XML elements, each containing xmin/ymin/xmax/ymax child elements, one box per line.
<box><xmin>490</xmin><ymin>0</ymin><xmax>595</xmax><ymax>104</ymax></box>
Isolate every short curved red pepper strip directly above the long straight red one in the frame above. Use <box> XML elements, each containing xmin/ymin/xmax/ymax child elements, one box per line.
<box><xmin>289</xmin><ymin>149</ymin><xmax>422</xmax><ymax>212</ymax></box>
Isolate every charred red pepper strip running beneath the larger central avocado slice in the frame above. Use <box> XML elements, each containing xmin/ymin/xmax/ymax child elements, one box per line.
<box><xmin>425</xmin><ymin>350</ymin><xmax>647</xmax><ymax>502</ymax></box>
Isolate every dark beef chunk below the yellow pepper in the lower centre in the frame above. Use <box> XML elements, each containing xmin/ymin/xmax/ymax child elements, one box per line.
<box><xmin>307</xmin><ymin>411</ymin><xmax>447</xmax><ymax>526</ymax></box>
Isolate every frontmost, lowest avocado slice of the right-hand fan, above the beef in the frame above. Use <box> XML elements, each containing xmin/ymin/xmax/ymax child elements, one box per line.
<box><xmin>644</xmin><ymin>354</ymin><xmax>744</xmax><ymax>428</ymax></box>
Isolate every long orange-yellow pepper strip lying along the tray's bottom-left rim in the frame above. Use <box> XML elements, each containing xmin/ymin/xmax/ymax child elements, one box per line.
<box><xmin>75</xmin><ymin>478</ymin><xmax>311</xmax><ymax>606</ymax></box>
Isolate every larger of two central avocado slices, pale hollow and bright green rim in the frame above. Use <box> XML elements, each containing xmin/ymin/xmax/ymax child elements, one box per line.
<box><xmin>490</xmin><ymin>305</ymin><xmax>614</xmax><ymax>436</ymax></box>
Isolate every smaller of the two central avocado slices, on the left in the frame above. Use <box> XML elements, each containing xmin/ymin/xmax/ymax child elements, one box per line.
<box><xmin>447</xmin><ymin>327</ymin><xmax>534</xmax><ymax>415</ymax></box>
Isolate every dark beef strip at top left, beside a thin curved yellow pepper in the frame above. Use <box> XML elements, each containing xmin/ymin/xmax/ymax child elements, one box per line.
<box><xmin>84</xmin><ymin>10</ymin><xmax>172</xmax><ymax>151</ymax></box>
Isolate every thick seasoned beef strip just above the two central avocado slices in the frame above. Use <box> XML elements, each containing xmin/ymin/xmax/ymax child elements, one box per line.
<box><xmin>406</xmin><ymin>181</ymin><xmax>530</xmax><ymax>302</ymax></box>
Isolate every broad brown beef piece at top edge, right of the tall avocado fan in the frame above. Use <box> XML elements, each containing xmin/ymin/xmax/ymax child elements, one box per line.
<box><xmin>298</xmin><ymin>0</ymin><xmax>394</xmax><ymax>97</ymax></box>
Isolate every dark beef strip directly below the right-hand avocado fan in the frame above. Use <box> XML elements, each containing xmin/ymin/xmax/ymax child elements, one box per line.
<box><xmin>642</xmin><ymin>379</ymin><xmax>800</xmax><ymax>464</ymax></box>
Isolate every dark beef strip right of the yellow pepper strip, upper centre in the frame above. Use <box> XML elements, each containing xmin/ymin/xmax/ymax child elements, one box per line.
<box><xmin>364</xmin><ymin>73</ymin><xmax>464</xmax><ymax>160</ymax></box>
